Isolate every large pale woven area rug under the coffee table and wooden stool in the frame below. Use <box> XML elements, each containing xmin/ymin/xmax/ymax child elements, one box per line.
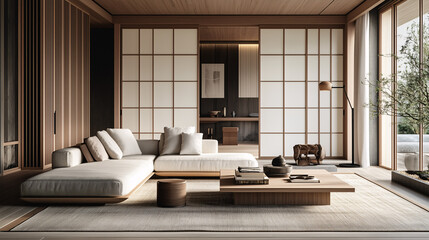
<box><xmin>12</xmin><ymin>174</ymin><xmax>429</xmax><ymax>232</ymax></box>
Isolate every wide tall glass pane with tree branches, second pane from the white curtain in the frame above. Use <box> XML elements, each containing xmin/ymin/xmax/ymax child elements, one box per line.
<box><xmin>396</xmin><ymin>0</ymin><xmax>420</xmax><ymax>170</ymax></box>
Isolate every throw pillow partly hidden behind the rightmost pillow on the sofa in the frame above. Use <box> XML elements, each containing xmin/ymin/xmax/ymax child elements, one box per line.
<box><xmin>161</xmin><ymin>127</ymin><xmax>195</xmax><ymax>155</ymax></box>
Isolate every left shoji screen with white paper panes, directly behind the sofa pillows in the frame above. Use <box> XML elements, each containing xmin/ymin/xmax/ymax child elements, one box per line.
<box><xmin>121</xmin><ymin>29</ymin><xmax>198</xmax><ymax>139</ymax></box>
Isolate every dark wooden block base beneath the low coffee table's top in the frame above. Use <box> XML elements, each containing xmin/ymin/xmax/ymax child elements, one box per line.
<box><xmin>233</xmin><ymin>192</ymin><xmax>331</xmax><ymax>205</ymax></box>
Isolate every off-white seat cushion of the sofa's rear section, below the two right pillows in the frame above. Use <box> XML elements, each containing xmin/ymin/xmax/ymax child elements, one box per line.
<box><xmin>154</xmin><ymin>153</ymin><xmax>258</xmax><ymax>172</ymax></box>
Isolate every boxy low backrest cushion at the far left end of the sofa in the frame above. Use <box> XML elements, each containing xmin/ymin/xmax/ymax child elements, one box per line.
<box><xmin>52</xmin><ymin>147</ymin><xmax>82</xmax><ymax>168</ymax></box>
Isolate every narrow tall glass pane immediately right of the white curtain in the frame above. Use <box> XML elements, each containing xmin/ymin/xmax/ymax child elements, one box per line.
<box><xmin>379</xmin><ymin>9</ymin><xmax>393</xmax><ymax>169</ymax></box>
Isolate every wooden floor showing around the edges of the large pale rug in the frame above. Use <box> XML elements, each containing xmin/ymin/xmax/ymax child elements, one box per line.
<box><xmin>0</xmin><ymin>148</ymin><xmax>429</xmax><ymax>240</ymax></box>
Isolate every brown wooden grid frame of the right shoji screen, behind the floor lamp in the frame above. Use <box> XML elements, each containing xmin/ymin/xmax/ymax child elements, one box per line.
<box><xmin>259</xmin><ymin>25</ymin><xmax>347</xmax><ymax>159</ymax></box>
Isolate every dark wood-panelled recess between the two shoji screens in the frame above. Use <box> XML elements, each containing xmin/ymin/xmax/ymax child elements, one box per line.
<box><xmin>200</xmin><ymin>42</ymin><xmax>259</xmax><ymax>143</ymax></box>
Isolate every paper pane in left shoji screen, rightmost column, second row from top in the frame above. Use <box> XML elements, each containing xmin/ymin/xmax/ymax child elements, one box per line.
<box><xmin>174</xmin><ymin>56</ymin><xmax>198</xmax><ymax>81</ymax></box>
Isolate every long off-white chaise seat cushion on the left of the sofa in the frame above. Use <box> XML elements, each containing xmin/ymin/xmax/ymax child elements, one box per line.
<box><xmin>21</xmin><ymin>158</ymin><xmax>155</xmax><ymax>197</ymax></box>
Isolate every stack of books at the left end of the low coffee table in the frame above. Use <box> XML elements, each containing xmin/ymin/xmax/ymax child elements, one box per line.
<box><xmin>235</xmin><ymin>167</ymin><xmax>269</xmax><ymax>185</ymax></box>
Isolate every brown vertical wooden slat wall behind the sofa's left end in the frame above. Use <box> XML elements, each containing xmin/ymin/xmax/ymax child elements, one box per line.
<box><xmin>22</xmin><ymin>0</ymin><xmax>90</xmax><ymax>168</ymax></box>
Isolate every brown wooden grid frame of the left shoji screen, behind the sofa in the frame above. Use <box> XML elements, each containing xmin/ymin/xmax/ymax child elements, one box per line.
<box><xmin>119</xmin><ymin>25</ymin><xmax>199</xmax><ymax>139</ymax></box>
